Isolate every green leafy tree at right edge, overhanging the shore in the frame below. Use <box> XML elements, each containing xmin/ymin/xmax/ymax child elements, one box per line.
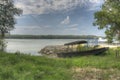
<box><xmin>93</xmin><ymin>0</ymin><xmax>120</xmax><ymax>42</ymax></box>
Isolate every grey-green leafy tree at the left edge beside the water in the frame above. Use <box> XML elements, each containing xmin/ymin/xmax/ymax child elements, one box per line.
<box><xmin>0</xmin><ymin>0</ymin><xmax>22</xmax><ymax>48</ymax></box>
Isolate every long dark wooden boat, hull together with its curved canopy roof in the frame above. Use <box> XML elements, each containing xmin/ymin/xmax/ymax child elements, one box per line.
<box><xmin>57</xmin><ymin>41</ymin><xmax>108</xmax><ymax>57</ymax></box>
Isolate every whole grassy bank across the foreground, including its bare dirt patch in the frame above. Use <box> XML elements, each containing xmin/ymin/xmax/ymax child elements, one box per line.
<box><xmin>0</xmin><ymin>49</ymin><xmax>120</xmax><ymax>80</ymax></box>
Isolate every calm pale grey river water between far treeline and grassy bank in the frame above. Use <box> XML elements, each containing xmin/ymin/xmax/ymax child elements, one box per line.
<box><xmin>6</xmin><ymin>39</ymin><xmax>98</xmax><ymax>55</ymax></box>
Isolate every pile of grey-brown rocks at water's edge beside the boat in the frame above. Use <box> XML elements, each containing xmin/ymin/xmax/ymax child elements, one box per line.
<box><xmin>40</xmin><ymin>45</ymin><xmax>71</xmax><ymax>57</ymax></box>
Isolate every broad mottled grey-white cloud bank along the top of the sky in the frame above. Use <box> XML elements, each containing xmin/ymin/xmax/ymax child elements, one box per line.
<box><xmin>15</xmin><ymin>0</ymin><xmax>101</xmax><ymax>14</ymax></box>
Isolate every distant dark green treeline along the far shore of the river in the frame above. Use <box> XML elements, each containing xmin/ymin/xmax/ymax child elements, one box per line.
<box><xmin>5</xmin><ymin>35</ymin><xmax>98</xmax><ymax>39</ymax></box>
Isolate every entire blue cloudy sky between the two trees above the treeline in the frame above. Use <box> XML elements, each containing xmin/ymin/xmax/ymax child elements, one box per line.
<box><xmin>11</xmin><ymin>0</ymin><xmax>104</xmax><ymax>36</ymax></box>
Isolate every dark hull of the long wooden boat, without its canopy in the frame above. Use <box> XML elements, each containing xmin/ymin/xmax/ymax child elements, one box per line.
<box><xmin>57</xmin><ymin>47</ymin><xmax>108</xmax><ymax>57</ymax></box>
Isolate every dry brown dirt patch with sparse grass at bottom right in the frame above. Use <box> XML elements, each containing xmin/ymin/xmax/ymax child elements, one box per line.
<box><xmin>73</xmin><ymin>68</ymin><xmax>120</xmax><ymax>80</ymax></box>
